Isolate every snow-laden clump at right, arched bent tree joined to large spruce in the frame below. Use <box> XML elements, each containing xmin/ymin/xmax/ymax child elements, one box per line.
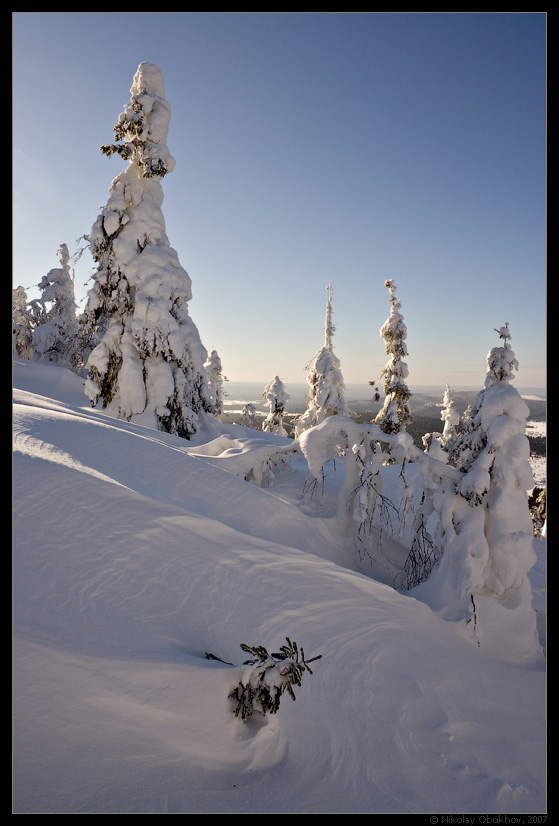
<box><xmin>299</xmin><ymin>325</ymin><xmax>540</xmax><ymax>662</ymax></box>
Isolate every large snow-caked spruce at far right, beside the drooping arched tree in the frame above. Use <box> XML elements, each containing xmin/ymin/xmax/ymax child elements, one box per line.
<box><xmin>420</xmin><ymin>324</ymin><xmax>542</xmax><ymax>664</ymax></box>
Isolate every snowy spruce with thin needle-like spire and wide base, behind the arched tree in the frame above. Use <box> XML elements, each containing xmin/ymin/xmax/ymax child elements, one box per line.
<box><xmin>294</xmin><ymin>284</ymin><xmax>348</xmax><ymax>437</ymax></box>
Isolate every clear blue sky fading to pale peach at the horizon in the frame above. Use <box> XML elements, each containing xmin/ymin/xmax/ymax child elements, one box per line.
<box><xmin>12</xmin><ymin>12</ymin><xmax>547</xmax><ymax>388</ymax></box>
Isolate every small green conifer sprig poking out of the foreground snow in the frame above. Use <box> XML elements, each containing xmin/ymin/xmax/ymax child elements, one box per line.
<box><xmin>229</xmin><ymin>637</ymin><xmax>322</xmax><ymax>723</ymax></box>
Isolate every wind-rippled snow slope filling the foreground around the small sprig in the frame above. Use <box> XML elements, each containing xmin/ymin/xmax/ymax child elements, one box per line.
<box><xmin>13</xmin><ymin>361</ymin><xmax>546</xmax><ymax>814</ymax></box>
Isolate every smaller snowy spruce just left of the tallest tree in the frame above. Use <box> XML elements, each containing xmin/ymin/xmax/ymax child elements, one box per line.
<box><xmin>33</xmin><ymin>244</ymin><xmax>82</xmax><ymax>372</ymax></box>
